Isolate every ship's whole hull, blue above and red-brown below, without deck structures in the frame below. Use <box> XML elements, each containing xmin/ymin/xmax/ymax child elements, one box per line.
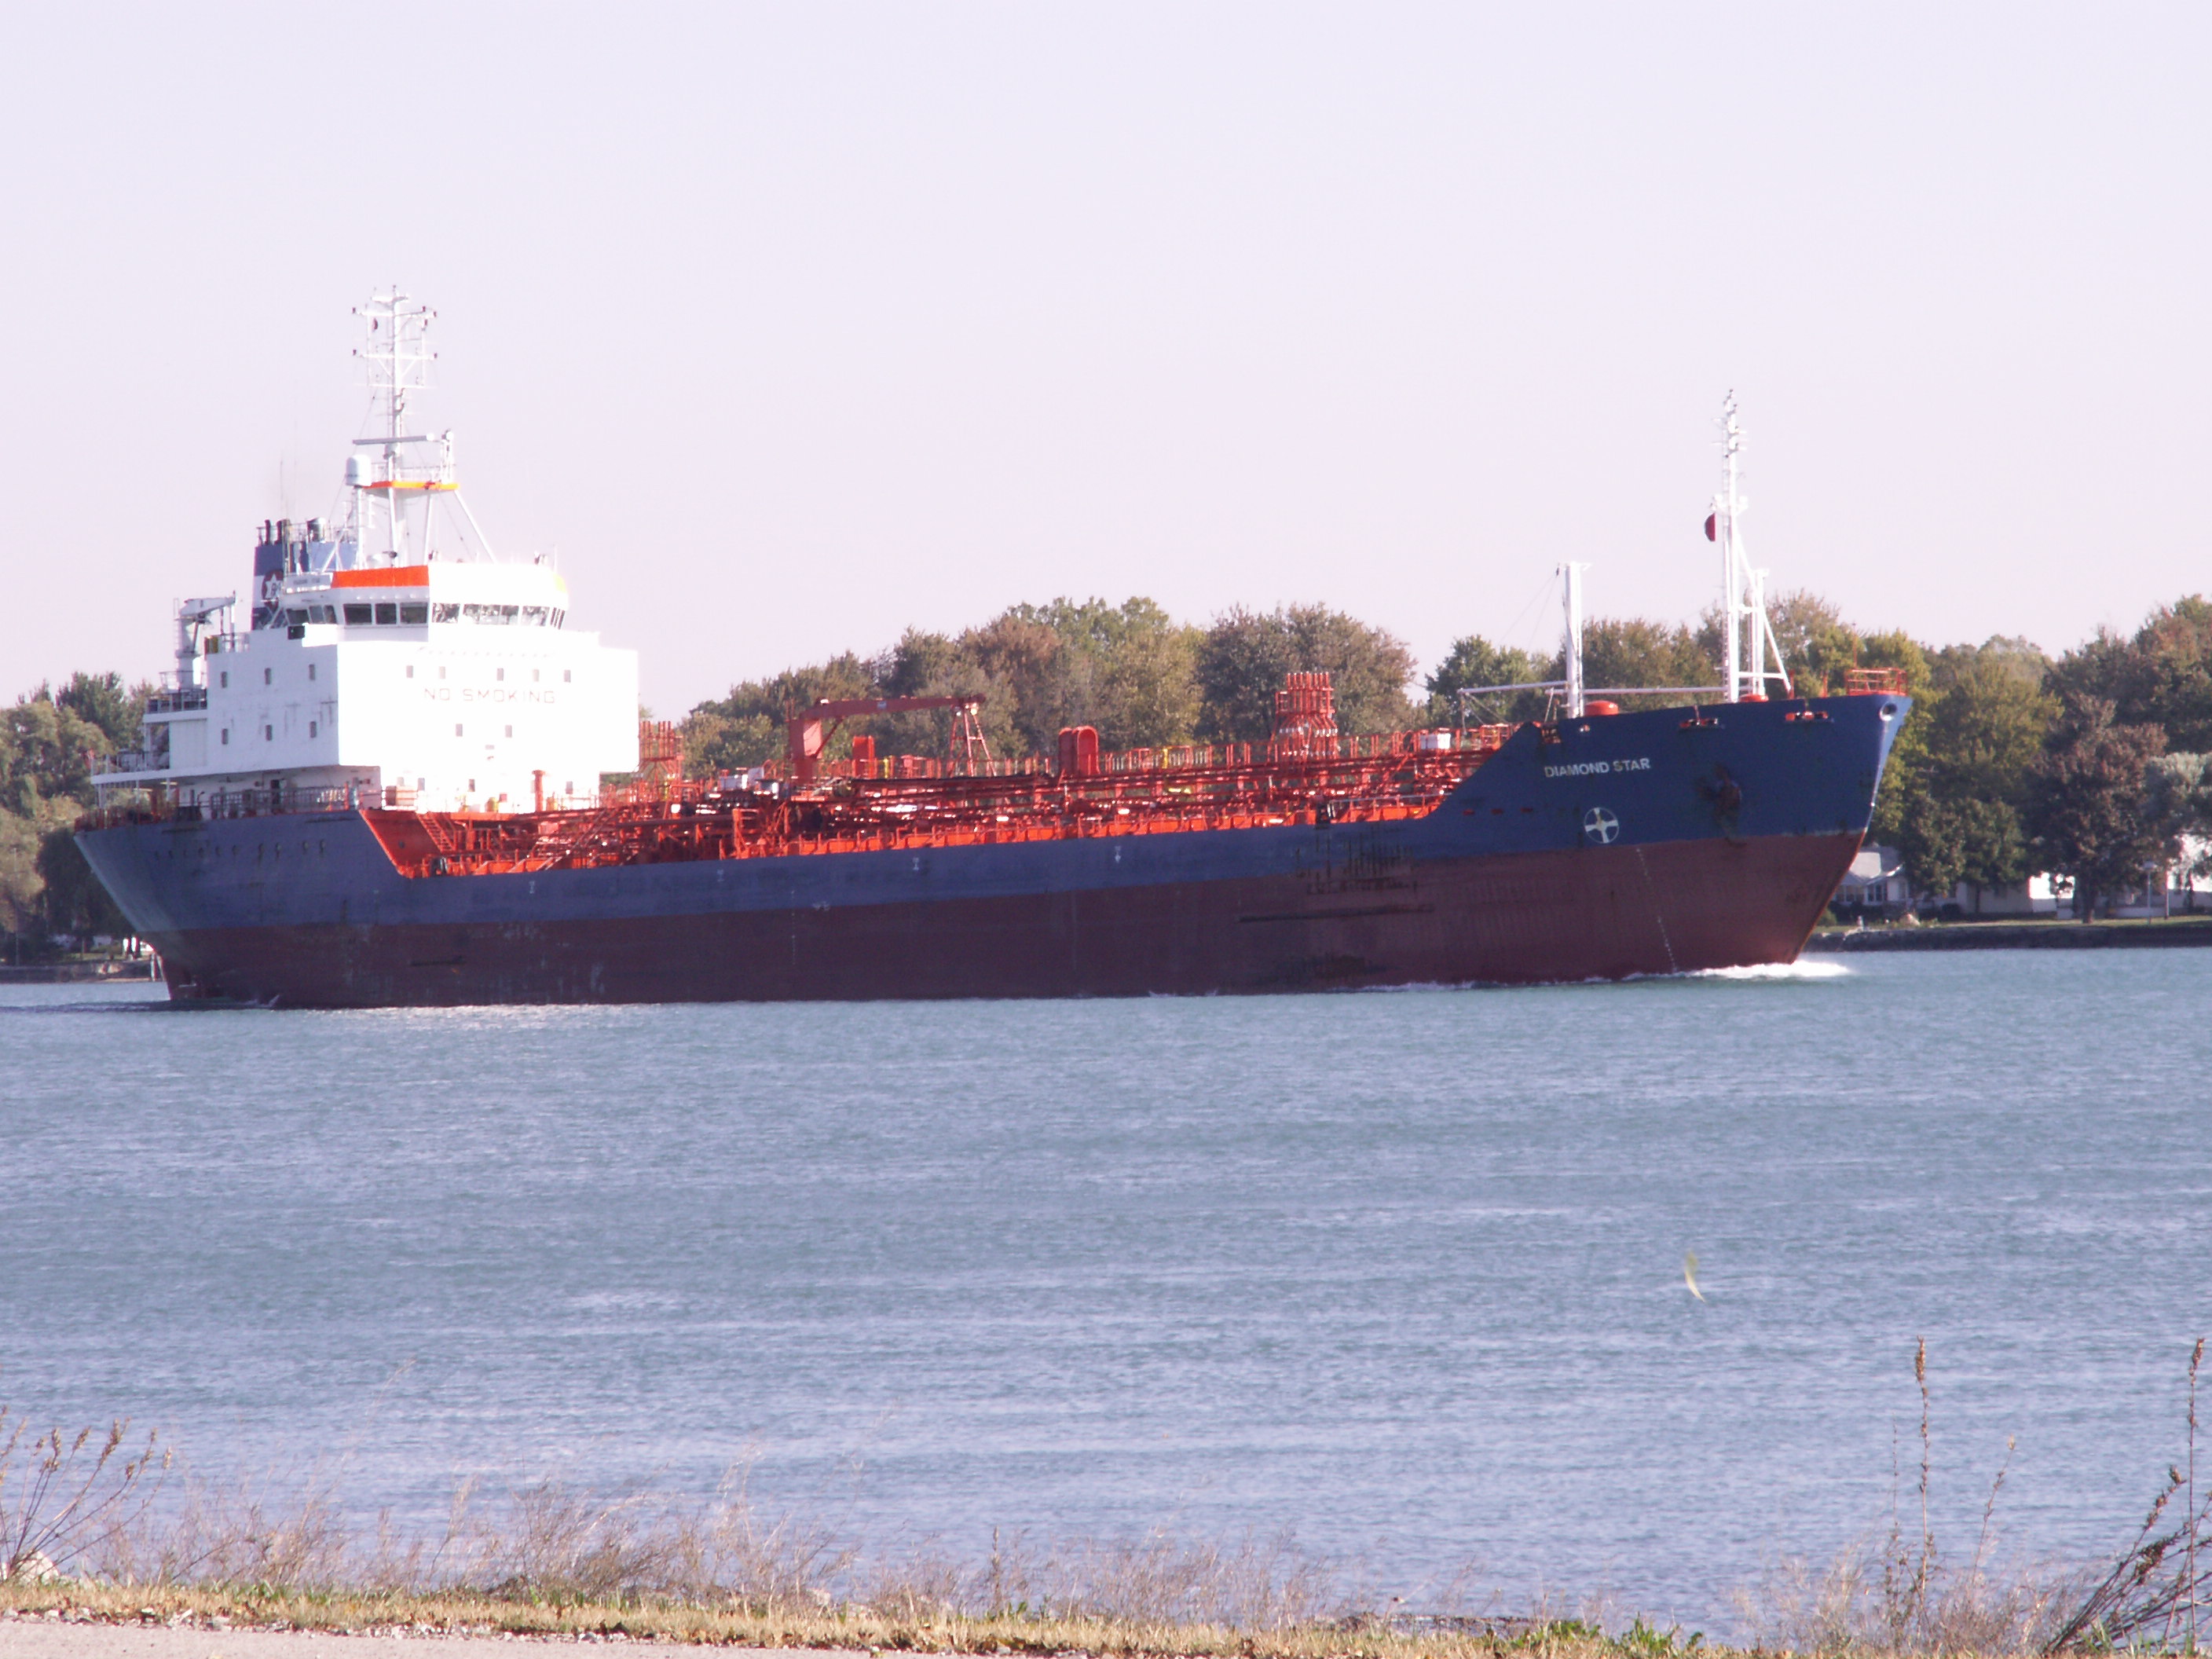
<box><xmin>79</xmin><ymin>697</ymin><xmax>1903</xmax><ymax>1006</ymax></box>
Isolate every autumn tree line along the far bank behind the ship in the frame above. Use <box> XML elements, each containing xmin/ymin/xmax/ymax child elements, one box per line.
<box><xmin>0</xmin><ymin>593</ymin><xmax>2212</xmax><ymax>954</ymax></box>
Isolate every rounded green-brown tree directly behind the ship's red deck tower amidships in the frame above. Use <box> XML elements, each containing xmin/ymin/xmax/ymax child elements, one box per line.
<box><xmin>1196</xmin><ymin>604</ymin><xmax>1418</xmax><ymax>743</ymax></box>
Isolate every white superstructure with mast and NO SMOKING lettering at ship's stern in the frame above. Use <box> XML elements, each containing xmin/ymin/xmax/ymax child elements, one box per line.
<box><xmin>95</xmin><ymin>292</ymin><xmax>637</xmax><ymax>827</ymax></box>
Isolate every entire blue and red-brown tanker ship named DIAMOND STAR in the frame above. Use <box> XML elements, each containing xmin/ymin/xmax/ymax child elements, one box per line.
<box><xmin>78</xmin><ymin>292</ymin><xmax>1909</xmax><ymax>1006</ymax></box>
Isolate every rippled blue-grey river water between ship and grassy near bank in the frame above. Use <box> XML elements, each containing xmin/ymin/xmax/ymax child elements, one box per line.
<box><xmin>0</xmin><ymin>951</ymin><xmax>2212</xmax><ymax>1628</ymax></box>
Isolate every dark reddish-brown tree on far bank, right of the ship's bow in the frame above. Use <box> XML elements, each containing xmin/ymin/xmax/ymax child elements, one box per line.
<box><xmin>2026</xmin><ymin>694</ymin><xmax>2172</xmax><ymax>922</ymax></box>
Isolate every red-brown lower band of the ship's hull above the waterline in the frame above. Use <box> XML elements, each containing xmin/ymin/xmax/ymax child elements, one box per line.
<box><xmin>155</xmin><ymin>834</ymin><xmax>1858</xmax><ymax>1006</ymax></box>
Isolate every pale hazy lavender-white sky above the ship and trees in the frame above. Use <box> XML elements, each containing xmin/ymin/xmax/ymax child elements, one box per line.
<box><xmin>0</xmin><ymin>0</ymin><xmax>2212</xmax><ymax>712</ymax></box>
